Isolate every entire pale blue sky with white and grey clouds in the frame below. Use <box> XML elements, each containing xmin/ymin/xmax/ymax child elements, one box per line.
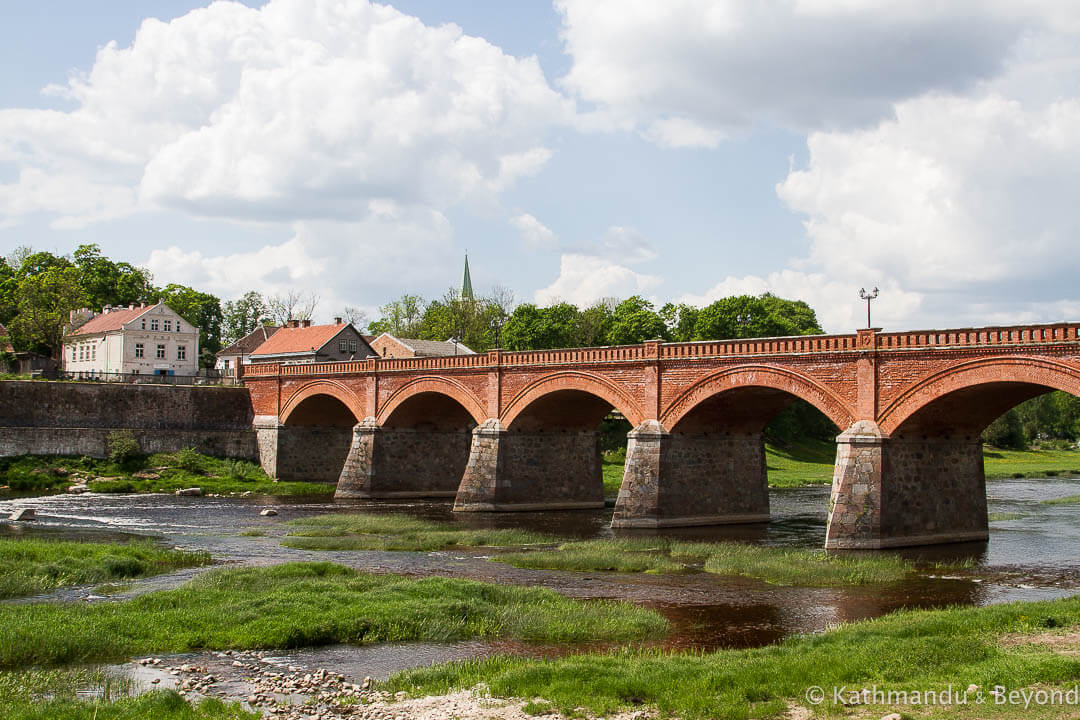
<box><xmin>0</xmin><ymin>0</ymin><xmax>1080</xmax><ymax>332</ymax></box>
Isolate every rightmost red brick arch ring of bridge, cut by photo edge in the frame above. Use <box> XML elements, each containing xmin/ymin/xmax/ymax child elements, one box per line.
<box><xmin>878</xmin><ymin>356</ymin><xmax>1080</xmax><ymax>435</ymax></box>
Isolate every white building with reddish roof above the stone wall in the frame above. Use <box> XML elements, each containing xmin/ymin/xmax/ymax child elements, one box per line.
<box><xmin>64</xmin><ymin>302</ymin><xmax>199</xmax><ymax>377</ymax></box>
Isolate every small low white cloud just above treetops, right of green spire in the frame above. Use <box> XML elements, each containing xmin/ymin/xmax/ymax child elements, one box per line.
<box><xmin>534</xmin><ymin>254</ymin><xmax>660</xmax><ymax>308</ymax></box>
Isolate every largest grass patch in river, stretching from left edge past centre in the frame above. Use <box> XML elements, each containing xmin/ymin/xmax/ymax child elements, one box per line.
<box><xmin>0</xmin><ymin>562</ymin><xmax>667</xmax><ymax>668</ymax></box>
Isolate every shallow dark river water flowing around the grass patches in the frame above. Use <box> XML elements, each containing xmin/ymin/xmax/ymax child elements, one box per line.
<box><xmin>0</xmin><ymin>477</ymin><xmax>1080</xmax><ymax>682</ymax></box>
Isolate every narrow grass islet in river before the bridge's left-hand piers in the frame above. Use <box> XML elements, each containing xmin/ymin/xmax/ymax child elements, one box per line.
<box><xmin>282</xmin><ymin>513</ymin><xmax>554</xmax><ymax>552</ymax></box>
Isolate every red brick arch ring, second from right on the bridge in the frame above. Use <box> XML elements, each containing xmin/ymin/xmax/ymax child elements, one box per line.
<box><xmin>660</xmin><ymin>365</ymin><xmax>854</xmax><ymax>430</ymax></box>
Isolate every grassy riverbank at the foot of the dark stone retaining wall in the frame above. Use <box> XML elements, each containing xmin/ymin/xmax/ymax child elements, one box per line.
<box><xmin>0</xmin><ymin>450</ymin><xmax>334</xmax><ymax>497</ymax></box>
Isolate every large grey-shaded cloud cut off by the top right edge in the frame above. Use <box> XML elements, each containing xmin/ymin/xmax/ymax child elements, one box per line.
<box><xmin>556</xmin><ymin>0</ymin><xmax>1080</xmax><ymax>141</ymax></box>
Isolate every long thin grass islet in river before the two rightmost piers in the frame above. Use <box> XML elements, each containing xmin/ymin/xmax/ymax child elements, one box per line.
<box><xmin>492</xmin><ymin>538</ymin><xmax>915</xmax><ymax>587</ymax></box>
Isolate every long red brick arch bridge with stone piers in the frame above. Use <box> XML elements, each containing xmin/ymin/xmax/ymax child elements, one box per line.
<box><xmin>243</xmin><ymin>324</ymin><xmax>1080</xmax><ymax>548</ymax></box>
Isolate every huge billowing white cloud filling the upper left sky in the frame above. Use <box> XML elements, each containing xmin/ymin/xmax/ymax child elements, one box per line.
<box><xmin>0</xmin><ymin>0</ymin><xmax>571</xmax><ymax>223</ymax></box>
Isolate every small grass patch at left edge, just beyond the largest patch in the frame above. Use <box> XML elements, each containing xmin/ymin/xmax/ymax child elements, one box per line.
<box><xmin>0</xmin><ymin>538</ymin><xmax>211</xmax><ymax>598</ymax></box>
